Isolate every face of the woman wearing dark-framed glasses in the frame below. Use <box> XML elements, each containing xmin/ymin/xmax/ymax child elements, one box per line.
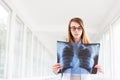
<box><xmin>70</xmin><ymin>22</ymin><xmax>82</xmax><ymax>40</ymax></box>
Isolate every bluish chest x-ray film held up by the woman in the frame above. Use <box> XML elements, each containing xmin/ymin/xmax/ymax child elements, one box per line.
<box><xmin>57</xmin><ymin>41</ymin><xmax>100</xmax><ymax>74</ymax></box>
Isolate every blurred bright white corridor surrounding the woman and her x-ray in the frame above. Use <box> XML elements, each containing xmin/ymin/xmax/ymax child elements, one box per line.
<box><xmin>0</xmin><ymin>0</ymin><xmax>120</xmax><ymax>80</ymax></box>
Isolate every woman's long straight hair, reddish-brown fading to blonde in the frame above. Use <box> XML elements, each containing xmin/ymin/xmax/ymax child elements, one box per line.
<box><xmin>67</xmin><ymin>17</ymin><xmax>90</xmax><ymax>44</ymax></box>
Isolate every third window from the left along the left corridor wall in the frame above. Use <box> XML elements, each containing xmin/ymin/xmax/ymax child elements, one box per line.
<box><xmin>25</xmin><ymin>28</ymin><xmax>32</xmax><ymax>77</ymax></box>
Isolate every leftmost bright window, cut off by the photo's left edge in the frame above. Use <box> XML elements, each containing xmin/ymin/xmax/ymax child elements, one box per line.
<box><xmin>0</xmin><ymin>4</ymin><xmax>10</xmax><ymax>78</ymax></box>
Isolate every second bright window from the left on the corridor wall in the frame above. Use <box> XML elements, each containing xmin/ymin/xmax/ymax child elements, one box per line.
<box><xmin>13</xmin><ymin>17</ymin><xmax>24</xmax><ymax>78</ymax></box>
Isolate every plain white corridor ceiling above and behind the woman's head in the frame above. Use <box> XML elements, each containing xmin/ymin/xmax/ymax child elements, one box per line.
<box><xmin>6</xmin><ymin>0</ymin><xmax>120</xmax><ymax>53</ymax></box>
